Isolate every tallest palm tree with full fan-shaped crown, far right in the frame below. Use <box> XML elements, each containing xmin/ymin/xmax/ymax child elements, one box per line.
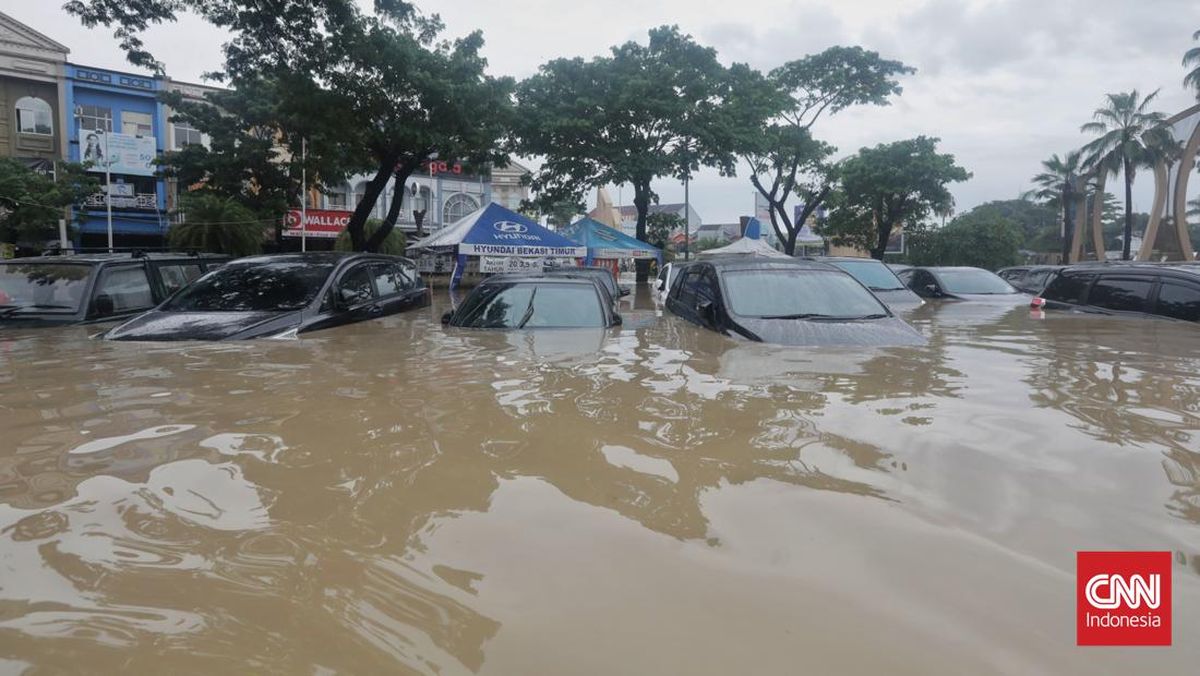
<box><xmin>1080</xmin><ymin>89</ymin><xmax>1177</xmax><ymax>261</ymax></box>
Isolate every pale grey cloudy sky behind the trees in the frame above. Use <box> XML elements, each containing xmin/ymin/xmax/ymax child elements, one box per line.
<box><xmin>11</xmin><ymin>0</ymin><xmax>1200</xmax><ymax>222</ymax></box>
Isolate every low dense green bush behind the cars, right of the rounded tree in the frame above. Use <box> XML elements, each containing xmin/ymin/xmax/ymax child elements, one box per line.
<box><xmin>908</xmin><ymin>209</ymin><xmax>1021</xmax><ymax>270</ymax></box>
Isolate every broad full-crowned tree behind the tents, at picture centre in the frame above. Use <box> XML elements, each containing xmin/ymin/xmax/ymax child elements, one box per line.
<box><xmin>514</xmin><ymin>26</ymin><xmax>758</xmax><ymax>282</ymax></box>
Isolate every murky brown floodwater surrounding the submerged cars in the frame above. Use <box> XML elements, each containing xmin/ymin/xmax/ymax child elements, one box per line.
<box><xmin>0</xmin><ymin>289</ymin><xmax>1200</xmax><ymax>675</ymax></box>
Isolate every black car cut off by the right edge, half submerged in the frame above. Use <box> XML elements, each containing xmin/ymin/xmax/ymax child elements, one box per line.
<box><xmin>1032</xmin><ymin>263</ymin><xmax>1200</xmax><ymax>322</ymax></box>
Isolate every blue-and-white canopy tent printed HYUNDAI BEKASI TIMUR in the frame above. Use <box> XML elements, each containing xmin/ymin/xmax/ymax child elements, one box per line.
<box><xmin>408</xmin><ymin>203</ymin><xmax>588</xmax><ymax>287</ymax></box>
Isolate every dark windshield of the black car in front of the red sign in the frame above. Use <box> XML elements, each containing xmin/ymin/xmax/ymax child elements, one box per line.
<box><xmin>163</xmin><ymin>261</ymin><xmax>334</xmax><ymax>312</ymax></box>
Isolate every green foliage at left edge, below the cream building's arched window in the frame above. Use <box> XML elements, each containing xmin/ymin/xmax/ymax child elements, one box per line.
<box><xmin>0</xmin><ymin>157</ymin><xmax>97</xmax><ymax>244</ymax></box>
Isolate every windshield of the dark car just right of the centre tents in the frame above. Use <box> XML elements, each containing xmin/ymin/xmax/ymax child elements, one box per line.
<box><xmin>722</xmin><ymin>269</ymin><xmax>888</xmax><ymax>319</ymax></box>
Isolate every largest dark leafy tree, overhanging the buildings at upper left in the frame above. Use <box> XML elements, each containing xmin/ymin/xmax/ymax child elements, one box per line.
<box><xmin>66</xmin><ymin>0</ymin><xmax>512</xmax><ymax>251</ymax></box>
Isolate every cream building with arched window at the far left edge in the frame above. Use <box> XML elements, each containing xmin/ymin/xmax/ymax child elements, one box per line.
<box><xmin>0</xmin><ymin>13</ymin><xmax>70</xmax><ymax>171</ymax></box>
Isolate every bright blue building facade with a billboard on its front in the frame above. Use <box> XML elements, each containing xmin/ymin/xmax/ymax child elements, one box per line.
<box><xmin>64</xmin><ymin>64</ymin><xmax>169</xmax><ymax>246</ymax></box>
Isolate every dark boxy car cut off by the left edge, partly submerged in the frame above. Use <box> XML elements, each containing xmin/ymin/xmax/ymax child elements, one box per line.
<box><xmin>0</xmin><ymin>252</ymin><xmax>229</xmax><ymax>327</ymax></box>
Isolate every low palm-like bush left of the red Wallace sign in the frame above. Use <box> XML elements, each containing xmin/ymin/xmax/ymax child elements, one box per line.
<box><xmin>167</xmin><ymin>190</ymin><xmax>274</xmax><ymax>256</ymax></box>
